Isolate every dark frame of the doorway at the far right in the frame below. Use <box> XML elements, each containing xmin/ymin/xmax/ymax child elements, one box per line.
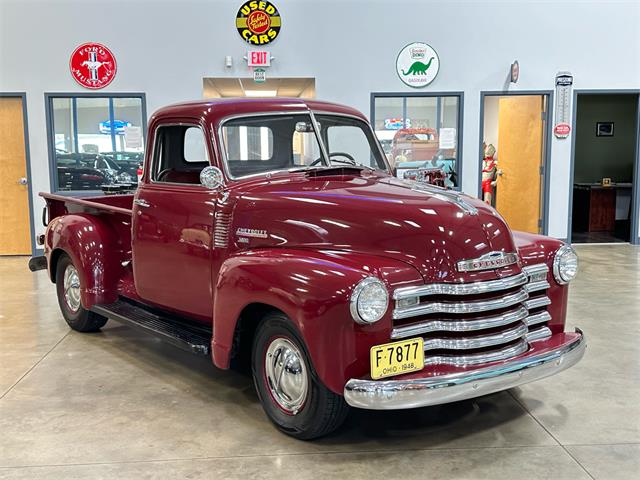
<box><xmin>567</xmin><ymin>89</ymin><xmax>640</xmax><ymax>245</ymax></box>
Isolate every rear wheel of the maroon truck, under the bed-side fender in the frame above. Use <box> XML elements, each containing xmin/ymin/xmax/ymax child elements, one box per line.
<box><xmin>56</xmin><ymin>254</ymin><xmax>107</xmax><ymax>332</ymax></box>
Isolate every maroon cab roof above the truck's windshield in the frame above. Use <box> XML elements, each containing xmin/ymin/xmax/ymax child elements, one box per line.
<box><xmin>151</xmin><ymin>97</ymin><xmax>367</xmax><ymax>124</ymax></box>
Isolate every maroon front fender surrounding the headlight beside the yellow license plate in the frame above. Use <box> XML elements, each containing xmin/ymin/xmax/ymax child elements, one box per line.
<box><xmin>212</xmin><ymin>249</ymin><xmax>422</xmax><ymax>395</ymax></box>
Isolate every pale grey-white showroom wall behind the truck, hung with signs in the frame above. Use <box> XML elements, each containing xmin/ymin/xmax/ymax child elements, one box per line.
<box><xmin>0</xmin><ymin>0</ymin><xmax>640</xmax><ymax>244</ymax></box>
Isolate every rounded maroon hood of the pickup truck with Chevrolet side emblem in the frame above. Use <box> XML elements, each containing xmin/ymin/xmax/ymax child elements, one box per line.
<box><xmin>230</xmin><ymin>170</ymin><xmax>519</xmax><ymax>283</ymax></box>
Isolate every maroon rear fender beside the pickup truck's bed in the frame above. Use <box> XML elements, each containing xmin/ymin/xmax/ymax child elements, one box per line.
<box><xmin>45</xmin><ymin>214</ymin><xmax>123</xmax><ymax>309</ymax></box>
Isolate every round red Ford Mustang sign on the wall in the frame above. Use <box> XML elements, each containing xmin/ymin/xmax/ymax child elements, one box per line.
<box><xmin>69</xmin><ymin>43</ymin><xmax>118</xmax><ymax>90</ymax></box>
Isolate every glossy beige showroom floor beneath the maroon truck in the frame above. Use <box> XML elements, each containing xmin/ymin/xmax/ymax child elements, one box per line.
<box><xmin>0</xmin><ymin>245</ymin><xmax>640</xmax><ymax>480</ymax></box>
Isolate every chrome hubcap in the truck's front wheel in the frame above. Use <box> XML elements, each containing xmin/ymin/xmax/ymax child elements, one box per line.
<box><xmin>264</xmin><ymin>338</ymin><xmax>309</xmax><ymax>415</ymax></box>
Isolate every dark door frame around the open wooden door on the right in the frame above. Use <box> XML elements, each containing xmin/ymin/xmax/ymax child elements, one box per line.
<box><xmin>478</xmin><ymin>90</ymin><xmax>554</xmax><ymax>235</ymax></box>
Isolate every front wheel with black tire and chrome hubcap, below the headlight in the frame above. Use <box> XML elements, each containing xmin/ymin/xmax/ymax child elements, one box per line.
<box><xmin>251</xmin><ymin>313</ymin><xmax>349</xmax><ymax>440</ymax></box>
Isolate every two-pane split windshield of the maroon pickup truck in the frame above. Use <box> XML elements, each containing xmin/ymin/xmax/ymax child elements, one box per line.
<box><xmin>221</xmin><ymin>114</ymin><xmax>387</xmax><ymax>178</ymax></box>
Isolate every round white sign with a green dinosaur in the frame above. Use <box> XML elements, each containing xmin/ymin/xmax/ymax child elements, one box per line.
<box><xmin>396</xmin><ymin>42</ymin><xmax>440</xmax><ymax>88</ymax></box>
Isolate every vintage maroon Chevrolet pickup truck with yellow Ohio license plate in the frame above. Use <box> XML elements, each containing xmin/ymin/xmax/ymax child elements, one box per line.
<box><xmin>30</xmin><ymin>98</ymin><xmax>585</xmax><ymax>439</ymax></box>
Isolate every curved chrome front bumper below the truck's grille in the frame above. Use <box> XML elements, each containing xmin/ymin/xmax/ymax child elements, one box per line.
<box><xmin>344</xmin><ymin>328</ymin><xmax>587</xmax><ymax>410</ymax></box>
